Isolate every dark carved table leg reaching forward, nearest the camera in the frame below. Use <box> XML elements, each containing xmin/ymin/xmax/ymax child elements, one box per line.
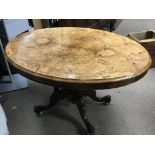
<box><xmin>74</xmin><ymin>97</ymin><xmax>95</xmax><ymax>135</ymax></box>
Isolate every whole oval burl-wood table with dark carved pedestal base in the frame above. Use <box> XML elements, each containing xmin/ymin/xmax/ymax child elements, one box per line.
<box><xmin>6</xmin><ymin>27</ymin><xmax>151</xmax><ymax>134</ymax></box>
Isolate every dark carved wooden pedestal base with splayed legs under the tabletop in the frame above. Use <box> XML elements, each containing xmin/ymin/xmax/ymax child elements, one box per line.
<box><xmin>34</xmin><ymin>87</ymin><xmax>111</xmax><ymax>135</ymax></box>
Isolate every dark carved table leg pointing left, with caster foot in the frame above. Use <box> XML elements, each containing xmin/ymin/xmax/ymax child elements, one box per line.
<box><xmin>34</xmin><ymin>88</ymin><xmax>60</xmax><ymax>115</ymax></box>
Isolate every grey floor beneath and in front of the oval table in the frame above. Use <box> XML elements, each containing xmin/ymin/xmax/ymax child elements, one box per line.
<box><xmin>3</xmin><ymin>69</ymin><xmax>155</xmax><ymax>135</ymax></box>
